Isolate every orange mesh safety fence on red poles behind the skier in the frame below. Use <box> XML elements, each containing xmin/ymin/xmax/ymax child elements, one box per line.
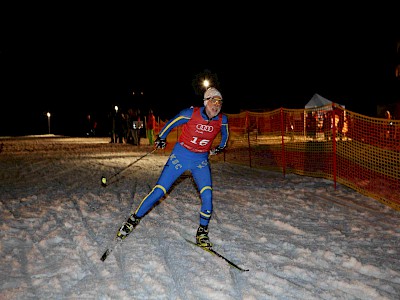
<box><xmin>156</xmin><ymin>104</ymin><xmax>400</xmax><ymax>210</ymax></box>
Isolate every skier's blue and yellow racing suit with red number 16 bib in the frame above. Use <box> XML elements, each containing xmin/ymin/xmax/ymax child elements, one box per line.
<box><xmin>135</xmin><ymin>107</ymin><xmax>229</xmax><ymax>226</ymax></box>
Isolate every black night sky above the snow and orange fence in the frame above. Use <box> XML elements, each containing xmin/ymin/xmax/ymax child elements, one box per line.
<box><xmin>0</xmin><ymin>7</ymin><xmax>399</xmax><ymax>135</ymax></box>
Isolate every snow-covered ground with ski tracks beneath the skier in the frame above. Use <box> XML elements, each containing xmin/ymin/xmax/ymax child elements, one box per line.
<box><xmin>0</xmin><ymin>136</ymin><xmax>400</xmax><ymax>300</ymax></box>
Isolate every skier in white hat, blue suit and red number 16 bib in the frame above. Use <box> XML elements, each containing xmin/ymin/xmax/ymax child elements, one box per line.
<box><xmin>117</xmin><ymin>87</ymin><xmax>229</xmax><ymax>248</ymax></box>
